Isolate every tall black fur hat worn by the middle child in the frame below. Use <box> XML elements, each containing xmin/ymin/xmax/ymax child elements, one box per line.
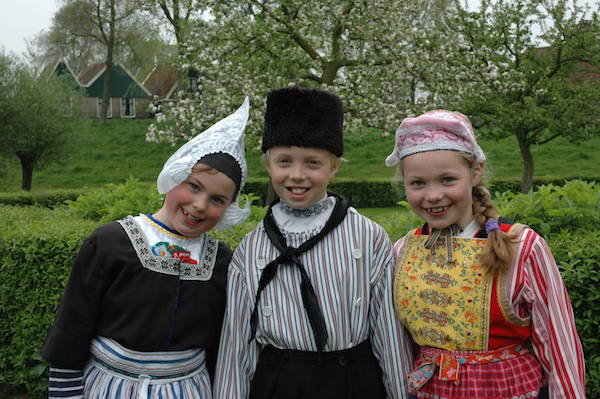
<box><xmin>262</xmin><ymin>87</ymin><xmax>344</xmax><ymax>157</ymax></box>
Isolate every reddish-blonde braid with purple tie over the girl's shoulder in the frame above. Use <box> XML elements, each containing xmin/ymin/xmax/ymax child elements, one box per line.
<box><xmin>473</xmin><ymin>182</ymin><xmax>515</xmax><ymax>275</ymax></box>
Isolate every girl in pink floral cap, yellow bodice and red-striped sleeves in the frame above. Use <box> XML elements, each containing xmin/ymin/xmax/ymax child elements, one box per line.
<box><xmin>386</xmin><ymin>110</ymin><xmax>585</xmax><ymax>399</ymax></box>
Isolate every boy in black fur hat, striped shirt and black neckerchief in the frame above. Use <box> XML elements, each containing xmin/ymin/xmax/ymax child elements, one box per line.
<box><xmin>214</xmin><ymin>88</ymin><xmax>412</xmax><ymax>399</ymax></box>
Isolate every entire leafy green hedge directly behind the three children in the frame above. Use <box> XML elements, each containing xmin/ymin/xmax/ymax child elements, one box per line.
<box><xmin>0</xmin><ymin>180</ymin><xmax>600</xmax><ymax>398</ymax></box>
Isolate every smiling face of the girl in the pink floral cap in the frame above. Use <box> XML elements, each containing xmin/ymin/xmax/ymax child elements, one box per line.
<box><xmin>402</xmin><ymin>151</ymin><xmax>483</xmax><ymax>229</ymax></box>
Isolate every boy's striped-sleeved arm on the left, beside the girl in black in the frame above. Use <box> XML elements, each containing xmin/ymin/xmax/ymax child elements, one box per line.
<box><xmin>213</xmin><ymin>242</ymin><xmax>259</xmax><ymax>399</ymax></box>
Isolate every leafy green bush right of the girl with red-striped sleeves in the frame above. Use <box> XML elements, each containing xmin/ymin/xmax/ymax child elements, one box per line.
<box><xmin>496</xmin><ymin>180</ymin><xmax>600</xmax><ymax>398</ymax></box>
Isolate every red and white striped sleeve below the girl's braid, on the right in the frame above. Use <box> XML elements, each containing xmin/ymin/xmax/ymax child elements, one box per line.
<box><xmin>513</xmin><ymin>228</ymin><xmax>585</xmax><ymax>399</ymax></box>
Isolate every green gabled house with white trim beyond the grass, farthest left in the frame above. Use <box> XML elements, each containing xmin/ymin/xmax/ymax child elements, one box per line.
<box><xmin>77</xmin><ymin>62</ymin><xmax>152</xmax><ymax>118</ymax></box>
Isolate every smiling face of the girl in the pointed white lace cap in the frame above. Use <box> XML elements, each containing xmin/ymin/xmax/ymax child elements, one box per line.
<box><xmin>154</xmin><ymin>169</ymin><xmax>235</xmax><ymax>237</ymax></box>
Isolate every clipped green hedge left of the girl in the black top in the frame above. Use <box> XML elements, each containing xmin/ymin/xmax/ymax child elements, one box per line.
<box><xmin>0</xmin><ymin>206</ymin><xmax>96</xmax><ymax>397</ymax></box>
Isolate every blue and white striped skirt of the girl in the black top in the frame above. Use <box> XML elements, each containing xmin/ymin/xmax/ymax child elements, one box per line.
<box><xmin>84</xmin><ymin>337</ymin><xmax>212</xmax><ymax>399</ymax></box>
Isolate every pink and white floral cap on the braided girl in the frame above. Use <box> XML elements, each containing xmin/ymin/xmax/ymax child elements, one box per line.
<box><xmin>385</xmin><ymin>109</ymin><xmax>485</xmax><ymax>166</ymax></box>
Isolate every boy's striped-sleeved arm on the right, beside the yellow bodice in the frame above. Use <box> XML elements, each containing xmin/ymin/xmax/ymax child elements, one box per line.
<box><xmin>369</xmin><ymin>225</ymin><xmax>414</xmax><ymax>398</ymax></box>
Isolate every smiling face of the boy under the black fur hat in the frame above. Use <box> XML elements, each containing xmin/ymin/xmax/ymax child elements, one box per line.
<box><xmin>267</xmin><ymin>146</ymin><xmax>339</xmax><ymax>209</ymax></box>
